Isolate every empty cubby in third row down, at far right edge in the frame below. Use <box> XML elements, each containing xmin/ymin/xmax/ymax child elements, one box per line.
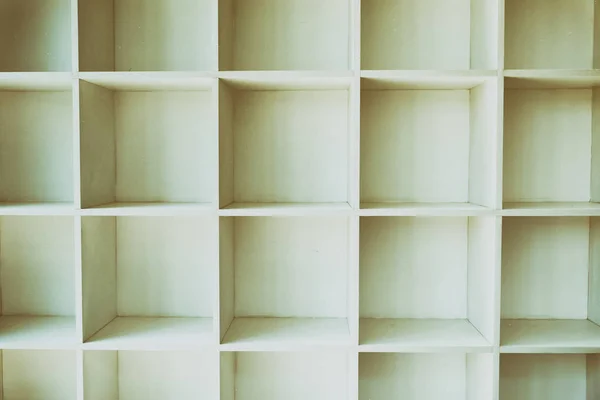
<box><xmin>500</xmin><ymin>217</ymin><xmax>600</xmax><ymax>353</ymax></box>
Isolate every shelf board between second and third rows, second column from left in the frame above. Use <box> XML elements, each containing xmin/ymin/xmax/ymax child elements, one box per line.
<box><xmin>81</xmin><ymin>202</ymin><xmax>216</xmax><ymax>216</ymax></box>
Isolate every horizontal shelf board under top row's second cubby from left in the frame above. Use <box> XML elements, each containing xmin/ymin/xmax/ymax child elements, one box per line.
<box><xmin>79</xmin><ymin>72</ymin><xmax>216</xmax><ymax>91</ymax></box>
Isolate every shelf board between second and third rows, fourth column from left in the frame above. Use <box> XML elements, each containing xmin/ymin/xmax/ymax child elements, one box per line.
<box><xmin>360</xmin><ymin>203</ymin><xmax>494</xmax><ymax>216</ymax></box>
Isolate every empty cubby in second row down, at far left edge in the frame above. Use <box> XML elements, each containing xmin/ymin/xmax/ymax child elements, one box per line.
<box><xmin>0</xmin><ymin>84</ymin><xmax>74</xmax><ymax>209</ymax></box>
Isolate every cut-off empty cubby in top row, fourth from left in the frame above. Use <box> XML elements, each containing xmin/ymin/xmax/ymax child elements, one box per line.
<box><xmin>361</xmin><ymin>0</ymin><xmax>499</xmax><ymax>70</ymax></box>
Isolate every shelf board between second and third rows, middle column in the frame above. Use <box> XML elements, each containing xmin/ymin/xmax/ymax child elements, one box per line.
<box><xmin>219</xmin><ymin>203</ymin><xmax>352</xmax><ymax>217</ymax></box>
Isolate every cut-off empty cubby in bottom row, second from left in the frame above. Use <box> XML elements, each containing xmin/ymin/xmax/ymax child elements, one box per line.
<box><xmin>83</xmin><ymin>350</ymin><xmax>219</xmax><ymax>400</ymax></box>
